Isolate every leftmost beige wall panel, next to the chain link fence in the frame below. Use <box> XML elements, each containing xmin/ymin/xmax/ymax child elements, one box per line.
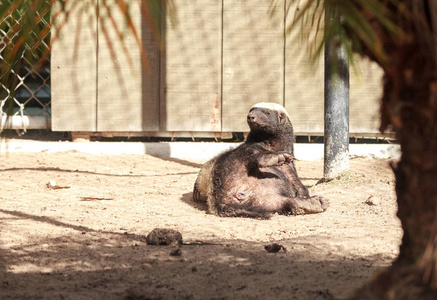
<box><xmin>51</xmin><ymin>0</ymin><xmax>97</xmax><ymax>131</ymax></box>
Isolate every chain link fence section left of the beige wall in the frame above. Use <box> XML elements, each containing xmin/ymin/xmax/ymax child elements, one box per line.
<box><xmin>0</xmin><ymin>0</ymin><xmax>51</xmax><ymax>132</ymax></box>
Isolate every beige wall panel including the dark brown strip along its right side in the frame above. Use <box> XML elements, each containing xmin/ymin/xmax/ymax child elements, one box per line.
<box><xmin>97</xmin><ymin>0</ymin><xmax>159</xmax><ymax>131</ymax></box>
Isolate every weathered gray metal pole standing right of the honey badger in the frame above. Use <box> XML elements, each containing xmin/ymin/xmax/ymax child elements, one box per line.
<box><xmin>323</xmin><ymin>16</ymin><xmax>349</xmax><ymax>180</ymax></box>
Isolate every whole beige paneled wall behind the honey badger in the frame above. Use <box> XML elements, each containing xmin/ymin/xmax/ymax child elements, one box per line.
<box><xmin>52</xmin><ymin>0</ymin><xmax>382</xmax><ymax>136</ymax></box>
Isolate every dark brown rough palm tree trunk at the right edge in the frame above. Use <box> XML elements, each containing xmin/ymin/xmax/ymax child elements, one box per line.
<box><xmin>353</xmin><ymin>2</ymin><xmax>437</xmax><ymax>299</ymax></box>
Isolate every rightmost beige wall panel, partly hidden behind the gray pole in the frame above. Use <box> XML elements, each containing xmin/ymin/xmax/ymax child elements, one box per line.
<box><xmin>285</xmin><ymin>0</ymin><xmax>382</xmax><ymax>136</ymax></box>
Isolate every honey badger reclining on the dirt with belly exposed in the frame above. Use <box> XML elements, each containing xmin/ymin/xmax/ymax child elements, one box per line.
<box><xmin>193</xmin><ymin>102</ymin><xmax>327</xmax><ymax>218</ymax></box>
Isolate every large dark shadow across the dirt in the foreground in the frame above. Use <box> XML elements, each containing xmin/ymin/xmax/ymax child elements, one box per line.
<box><xmin>0</xmin><ymin>210</ymin><xmax>388</xmax><ymax>299</ymax></box>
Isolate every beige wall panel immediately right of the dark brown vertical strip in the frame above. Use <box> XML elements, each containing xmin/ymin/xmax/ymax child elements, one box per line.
<box><xmin>161</xmin><ymin>0</ymin><xmax>222</xmax><ymax>131</ymax></box>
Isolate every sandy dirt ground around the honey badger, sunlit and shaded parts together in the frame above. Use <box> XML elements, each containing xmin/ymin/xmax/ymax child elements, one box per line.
<box><xmin>0</xmin><ymin>151</ymin><xmax>402</xmax><ymax>300</ymax></box>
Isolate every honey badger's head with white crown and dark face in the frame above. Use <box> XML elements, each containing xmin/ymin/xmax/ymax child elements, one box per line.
<box><xmin>247</xmin><ymin>102</ymin><xmax>292</xmax><ymax>134</ymax></box>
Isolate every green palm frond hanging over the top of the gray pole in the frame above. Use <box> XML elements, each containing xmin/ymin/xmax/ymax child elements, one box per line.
<box><xmin>286</xmin><ymin>0</ymin><xmax>408</xmax><ymax>65</ymax></box>
